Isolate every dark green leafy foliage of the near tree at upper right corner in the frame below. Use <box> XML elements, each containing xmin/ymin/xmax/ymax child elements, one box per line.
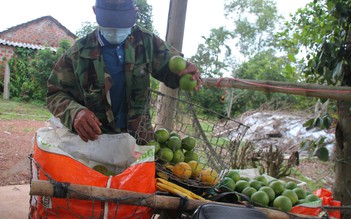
<box><xmin>276</xmin><ymin>0</ymin><xmax>351</xmax><ymax>85</ymax></box>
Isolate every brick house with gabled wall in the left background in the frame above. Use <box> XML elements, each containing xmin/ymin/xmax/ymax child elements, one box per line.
<box><xmin>0</xmin><ymin>16</ymin><xmax>77</xmax><ymax>99</ymax></box>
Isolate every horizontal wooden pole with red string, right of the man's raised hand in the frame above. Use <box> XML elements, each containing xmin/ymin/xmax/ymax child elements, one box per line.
<box><xmin>202</xmin><ymin>78</ymin><xmax>351</xmax><ymax>101</ymax></box>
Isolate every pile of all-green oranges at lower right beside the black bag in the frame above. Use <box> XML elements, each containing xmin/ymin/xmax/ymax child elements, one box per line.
<box><xmin>216</xmin><ymin>170</ymin><xmax>319</xmax><ymax>212</ymax></box>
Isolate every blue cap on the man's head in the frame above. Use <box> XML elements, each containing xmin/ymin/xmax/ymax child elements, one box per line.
<box><xmin>95</xmin><ymin>0</ymin><xmax>136</xmax><ymax>28</ymax></box>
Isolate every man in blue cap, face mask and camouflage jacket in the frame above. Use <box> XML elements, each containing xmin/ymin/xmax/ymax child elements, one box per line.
<box><xmin>47</xmin><ymin>0</ymin><xmax>201</xmax><ymax>142</ymax></box>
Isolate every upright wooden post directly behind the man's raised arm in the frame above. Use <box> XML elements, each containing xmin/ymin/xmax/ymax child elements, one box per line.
<box><xmin>156</xmin><ymin>0</ymin><xmax>188</xmax><ymax>130</ymax></box>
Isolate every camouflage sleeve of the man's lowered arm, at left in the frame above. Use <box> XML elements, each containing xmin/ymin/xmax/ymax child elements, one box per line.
<box><xmin>46</xmin><ymin>54</ymin><xmax>85</xmax><ymax>131</ymax></box>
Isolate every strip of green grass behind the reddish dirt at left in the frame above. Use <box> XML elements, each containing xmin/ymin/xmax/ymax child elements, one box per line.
<box><xmin>0</xmin><ymin>99</ymin><xmax>51</xmax><ymax>121</ymax></box>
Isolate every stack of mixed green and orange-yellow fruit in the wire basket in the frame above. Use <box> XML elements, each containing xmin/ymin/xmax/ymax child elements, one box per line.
<box><xmin>148</xmin><ymin>128</ymin><xmax>219</xmax><ymax>187</ymax></box>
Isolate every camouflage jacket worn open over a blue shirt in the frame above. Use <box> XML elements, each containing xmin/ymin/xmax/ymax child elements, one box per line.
<box><xmin>47</xmin><ymin>26</ymin><xmax>180</xmax><ymax>133</ymax></box>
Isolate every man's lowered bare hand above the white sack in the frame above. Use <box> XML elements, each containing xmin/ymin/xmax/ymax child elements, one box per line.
<box><xmin>73</xmin><ymin>109</ymin><xmax>102</xmax><ymax>142</ymax></box>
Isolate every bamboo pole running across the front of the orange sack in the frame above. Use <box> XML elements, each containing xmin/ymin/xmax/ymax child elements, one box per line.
<box><xmin>29</xmin><ymin>180</ymin><xmax>316</xmax><ymax>219</ymax></box>
